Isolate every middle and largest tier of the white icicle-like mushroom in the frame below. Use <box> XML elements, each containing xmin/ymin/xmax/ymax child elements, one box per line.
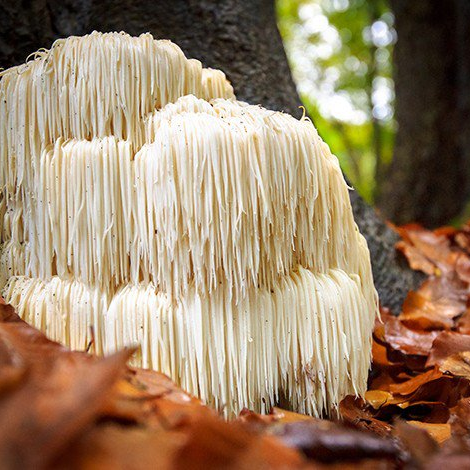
<box><xmin>0</xmin><ymin>95</ymin><xmax>374</xmax><ymax>302</ymax></box>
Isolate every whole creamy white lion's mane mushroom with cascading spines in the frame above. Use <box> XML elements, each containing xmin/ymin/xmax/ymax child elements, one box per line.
<box><xmin>0</xmin><ymin>32</ymin><xmax>377</xmax><ymax>415</ymax></box>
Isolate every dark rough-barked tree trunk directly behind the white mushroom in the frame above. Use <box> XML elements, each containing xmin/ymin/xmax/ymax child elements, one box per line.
<box><xmin>0</xmin><ymin>0</ymin><xmax>419</xmax><ymax>311</ymax></box>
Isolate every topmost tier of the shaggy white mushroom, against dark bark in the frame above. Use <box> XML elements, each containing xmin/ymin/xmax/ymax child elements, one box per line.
<box><xmin>0</xmin><ymin>31</ymin><xmax>234</xmax><ymax>199</ymax></box>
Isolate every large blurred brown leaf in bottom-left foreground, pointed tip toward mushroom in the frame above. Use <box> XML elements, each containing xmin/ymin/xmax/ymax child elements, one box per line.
<box><xmin>0</xmin><ymin>346</ymin><xmax>129</xmax><ymax>468</ymax></box>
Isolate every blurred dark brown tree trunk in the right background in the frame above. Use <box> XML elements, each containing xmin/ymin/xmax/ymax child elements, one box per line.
<box><xmin>379</xmin><ymin>0</ymin><xmax>470</xmax><ymax>226</ymax></box>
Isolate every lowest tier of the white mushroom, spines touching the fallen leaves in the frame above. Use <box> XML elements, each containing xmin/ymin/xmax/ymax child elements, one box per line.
<box><xmin>0</xmin><ymin>267</ymin><xmax>375</xmax><ymax>416</ymax></box>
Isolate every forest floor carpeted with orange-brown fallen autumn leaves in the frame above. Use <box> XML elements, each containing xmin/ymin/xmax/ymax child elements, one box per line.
<box><xmin>0</xmin><ymin>225</ymin><xmax>470</xmax><ymax>470</ymax></box>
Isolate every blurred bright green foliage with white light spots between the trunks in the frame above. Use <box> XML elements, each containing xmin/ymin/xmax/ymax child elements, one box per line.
<box><xmin>277</xmin><ymin>0</ymin><xmax>396</xmax><ymax>202</ymax></box>
